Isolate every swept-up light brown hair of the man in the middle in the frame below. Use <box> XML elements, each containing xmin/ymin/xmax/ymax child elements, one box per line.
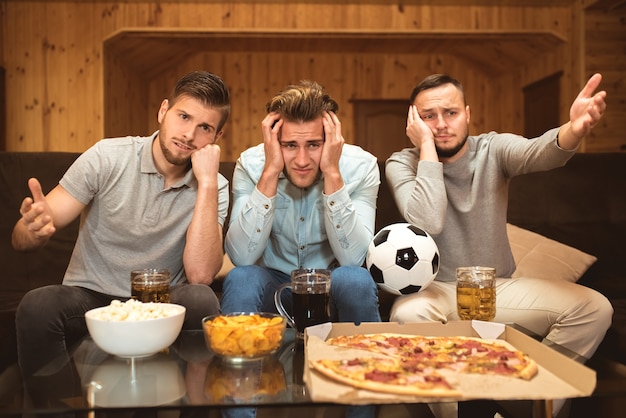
<box><xmin>265</xmin><ymin>80</ymin><xmax>339</xmax><ymax>122</ymax></box>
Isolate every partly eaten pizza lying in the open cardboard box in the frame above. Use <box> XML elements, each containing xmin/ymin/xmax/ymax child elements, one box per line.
<box><xmin>311</xmin><ymin>333</ymin><xmax>538</xmax><ymax>397</ymax></box>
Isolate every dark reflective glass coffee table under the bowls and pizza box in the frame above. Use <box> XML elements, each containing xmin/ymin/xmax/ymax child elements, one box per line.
<box><xmin>0</xmin><ymin>329</ymin><xmax>626</xmax><ymax>417</ymax></box>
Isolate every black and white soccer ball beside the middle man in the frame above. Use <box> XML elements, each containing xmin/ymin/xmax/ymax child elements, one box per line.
<box><xmin>365</xmin><ymin>223</ymin><xmax>439</xmax><ymax>295</ymax></box>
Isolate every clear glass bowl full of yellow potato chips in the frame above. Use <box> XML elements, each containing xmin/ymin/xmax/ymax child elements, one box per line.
<box><xmin>202</xmin><ymin>312</ymin><xmax>286</xmax><ymax>362</ymax></box>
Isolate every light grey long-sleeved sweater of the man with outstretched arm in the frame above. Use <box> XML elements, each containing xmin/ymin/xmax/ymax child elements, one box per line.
<box><xmin>385</xmin><ymin>128</ymin><xmax>575</xmax><ymax>281</ymax></box>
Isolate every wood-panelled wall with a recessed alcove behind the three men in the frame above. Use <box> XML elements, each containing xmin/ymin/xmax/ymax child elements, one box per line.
<box><xmin>0</xmin><ymin>0</ymin><xmax>626</xmax><ymax>160</ymax></box>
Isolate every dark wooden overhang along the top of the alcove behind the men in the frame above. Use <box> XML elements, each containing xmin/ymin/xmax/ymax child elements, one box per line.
<box><xmin>105</xmin><ymin>28</ymin><xmax>565</xmax><ymax>77</ymax></box>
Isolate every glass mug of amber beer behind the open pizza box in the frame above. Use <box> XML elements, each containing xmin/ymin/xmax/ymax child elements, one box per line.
<box><xmin>456</xmin><ymin>266</ymin><xmax>496</xmax><ymax>321</ymax></box>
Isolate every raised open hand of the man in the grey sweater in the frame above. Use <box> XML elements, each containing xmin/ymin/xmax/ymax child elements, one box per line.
<box><xmin>569</xmin><ymin>74</ymin><xmax>606</xmax><ymax>138</ymax></box>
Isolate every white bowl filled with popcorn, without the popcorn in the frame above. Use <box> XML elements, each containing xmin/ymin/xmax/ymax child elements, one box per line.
<box><xmin>85</xmin><ymin>303</ymin><xmax>185</xmax><ymax>358</ymax></box>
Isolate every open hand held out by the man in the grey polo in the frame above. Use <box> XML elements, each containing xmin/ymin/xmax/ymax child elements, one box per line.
<box><xmin>20</xmin><ymin>178</ymin><xmax>56</xmax><ymax>239</ymax></box>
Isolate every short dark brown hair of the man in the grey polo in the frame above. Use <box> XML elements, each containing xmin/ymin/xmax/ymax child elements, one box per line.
<box><xmin>169</xmin><ymin>71</ymin><xmax>230</xmax><ymax>132</ymax></box>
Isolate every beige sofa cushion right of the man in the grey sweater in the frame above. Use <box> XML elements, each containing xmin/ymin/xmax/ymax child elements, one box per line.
<box><xmin>507</xmin><ymin>224</ymin><xmax>597</xmax><ymax>282</ymax></box>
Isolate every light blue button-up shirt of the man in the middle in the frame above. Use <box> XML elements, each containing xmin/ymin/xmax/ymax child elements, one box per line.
<box><xmin>225</xmin><ymin>144</ymin><xmax>380</xmax><ymax>274</ymax></box>
